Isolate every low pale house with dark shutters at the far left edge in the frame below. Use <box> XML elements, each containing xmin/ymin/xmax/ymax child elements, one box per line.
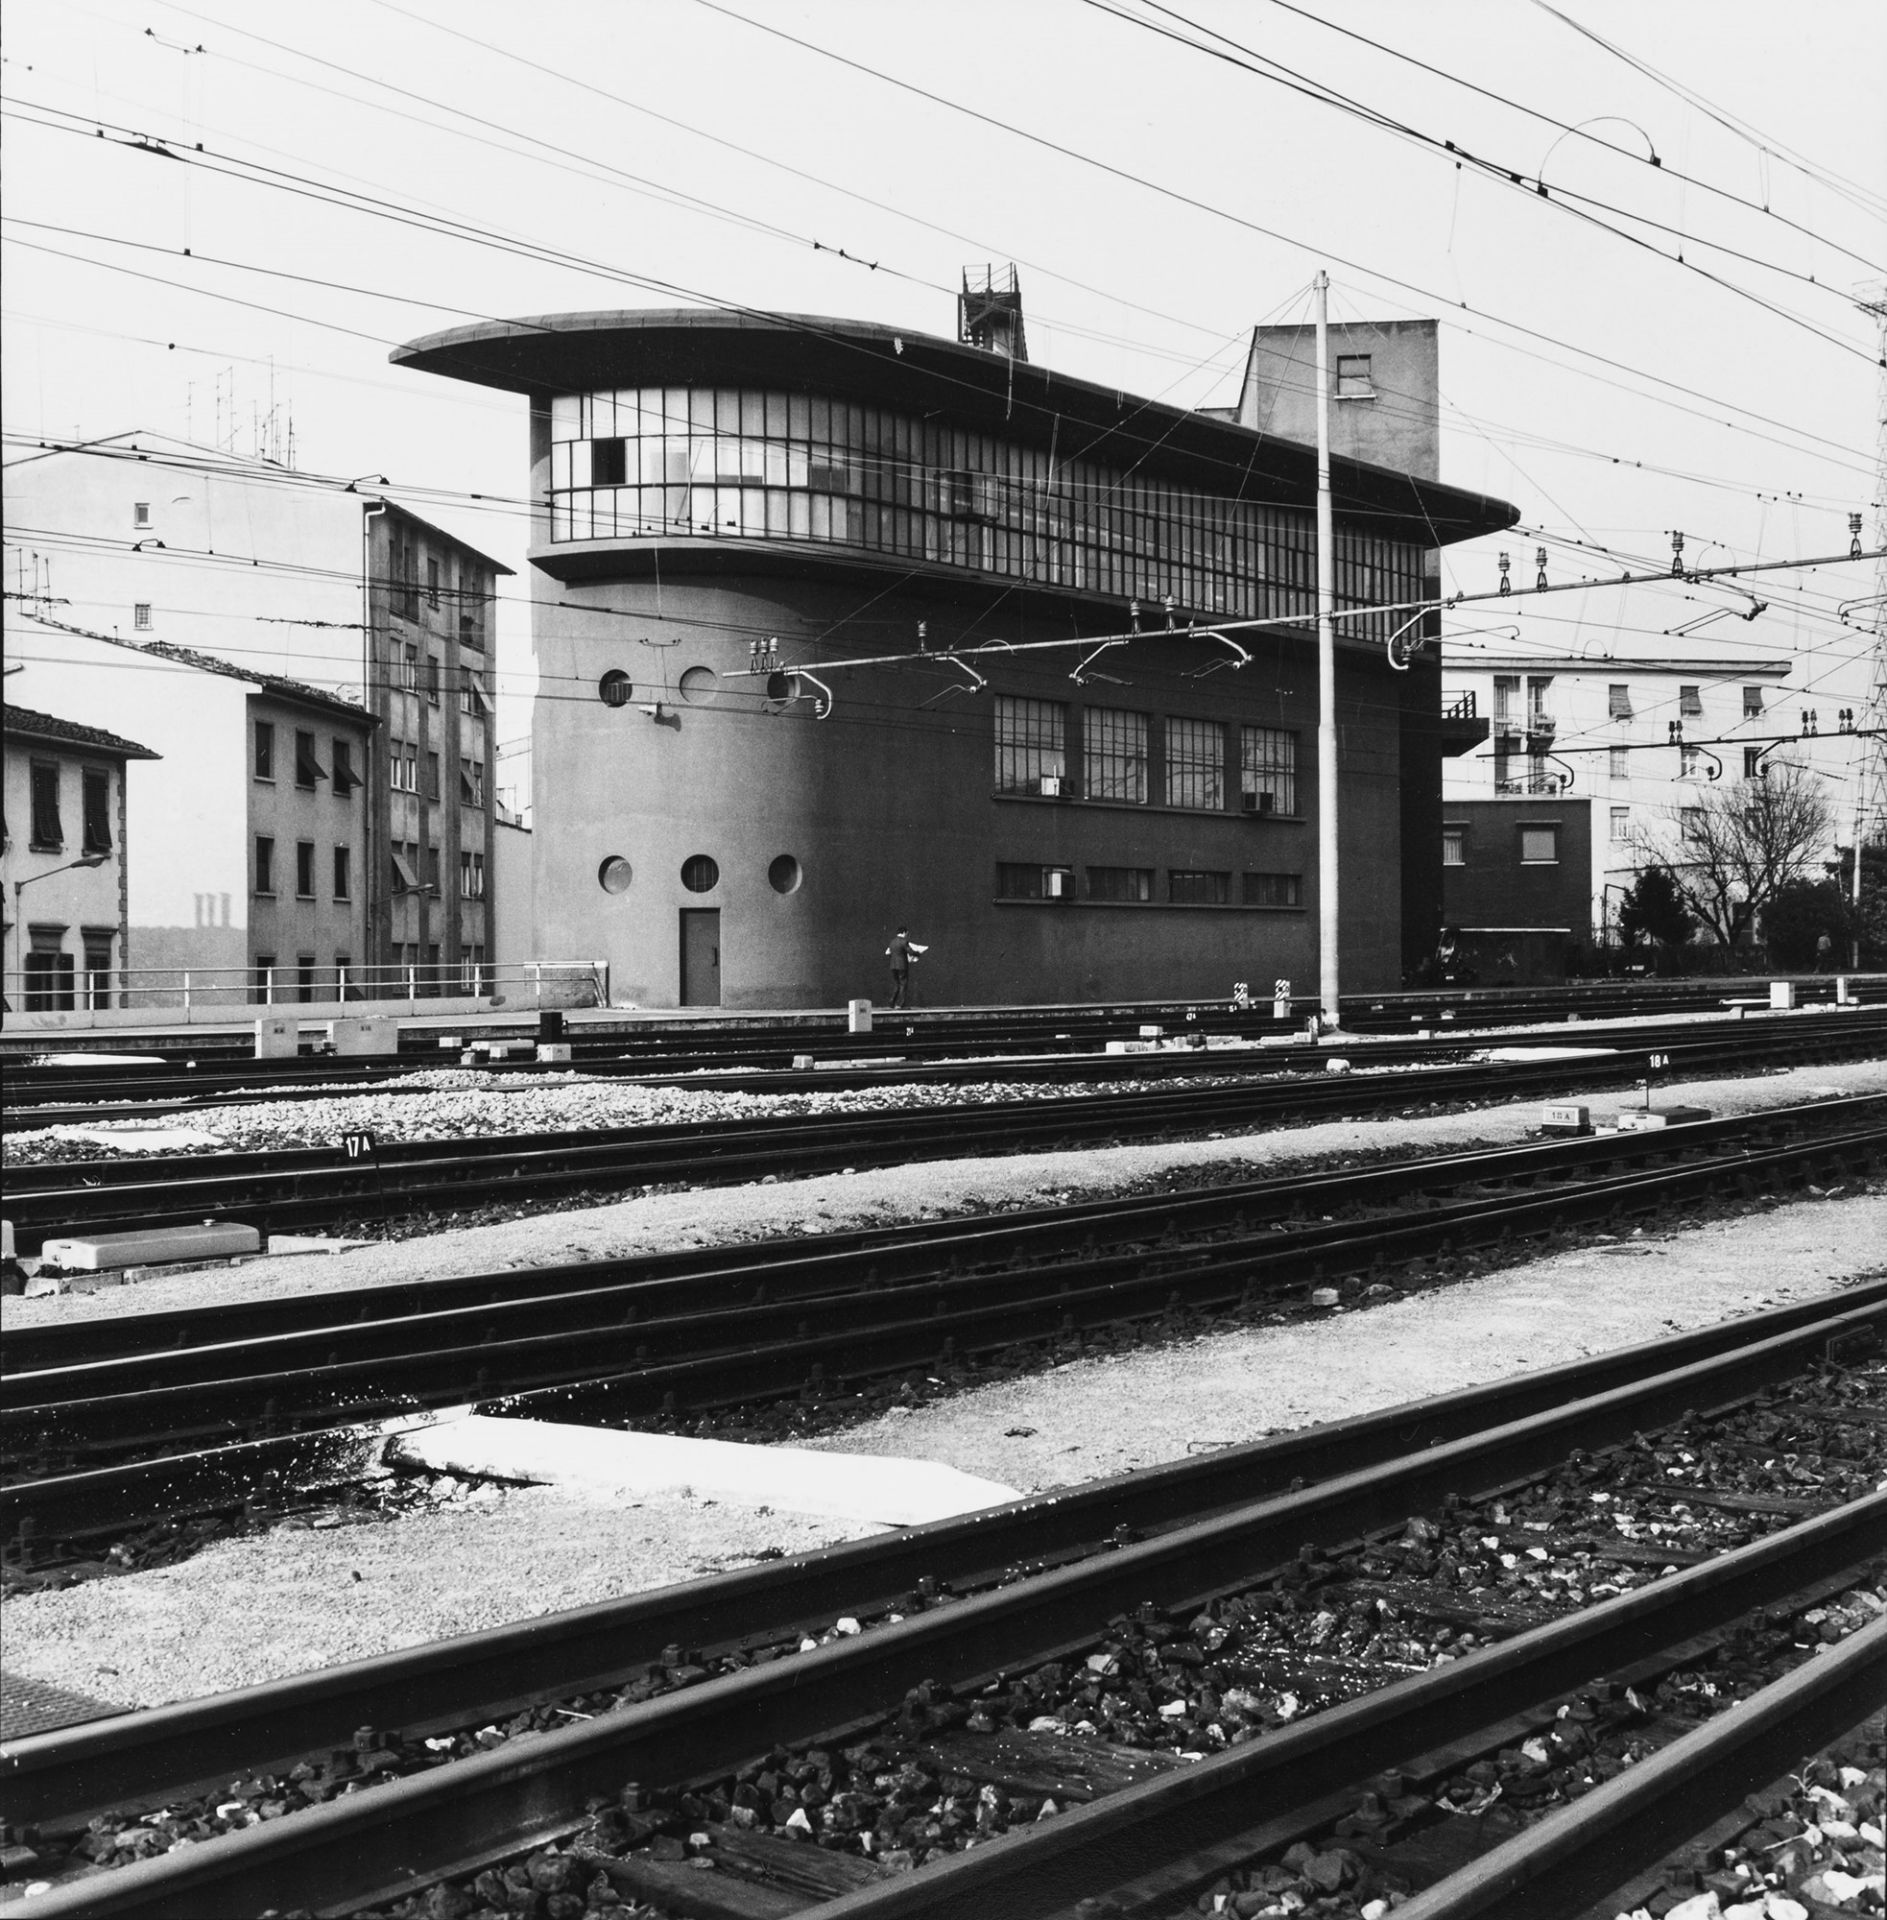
<box><xmin>0</xmin><ymin>703</ymin><xmax>157</xmax><ymax>1012</ymax></box>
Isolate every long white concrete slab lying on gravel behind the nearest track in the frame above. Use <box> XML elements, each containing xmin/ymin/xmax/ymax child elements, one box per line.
<box><xmin>386</xmin><ymin>1413</ymin><xmax>1021</xmax><ymax>1526</ymax></box>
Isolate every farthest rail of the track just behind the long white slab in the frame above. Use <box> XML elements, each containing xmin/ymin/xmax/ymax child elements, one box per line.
<box><xmin>14</xmin><ymin>1092</ymin><xmax>1887</xmax><ymax>1380</ymax></box>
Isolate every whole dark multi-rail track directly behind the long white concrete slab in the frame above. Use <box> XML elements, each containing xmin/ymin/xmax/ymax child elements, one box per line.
<box><xmin>0</xmin><ymin>1094</ymin><xmax>1887</xmax><ymax>1551</ymax></box>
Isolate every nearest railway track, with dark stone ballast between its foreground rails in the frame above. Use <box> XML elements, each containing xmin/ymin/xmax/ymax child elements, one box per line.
<box><xmin>0</xmin><ymin>1281</ymin><xmax>1887</xmax><ymax>1920</ymax></box>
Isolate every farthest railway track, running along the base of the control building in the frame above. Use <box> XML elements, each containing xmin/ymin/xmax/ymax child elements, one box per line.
<box><xmin>6</xmin><ymin>981</ymin><xmax>1866</xmax><ymax>1129</ymax></box>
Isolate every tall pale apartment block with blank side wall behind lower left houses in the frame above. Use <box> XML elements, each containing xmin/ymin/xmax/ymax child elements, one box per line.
<box><xmin>6</xmin><ymin>434</ymin><xmax>510</xmax><ymax>975</ymax></box>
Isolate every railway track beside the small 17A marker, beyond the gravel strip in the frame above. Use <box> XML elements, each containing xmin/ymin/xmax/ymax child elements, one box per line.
<box><xmin>8</xmin><ymin>1010</ymin><xmax>1887</xmax><ymax>1252</ymax></box>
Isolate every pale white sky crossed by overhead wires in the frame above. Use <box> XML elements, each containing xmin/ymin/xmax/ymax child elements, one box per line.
<box><xmin>4</xmin><ymin>0</ymin><xmax>1887</xmax><ymax>779</ymax></box>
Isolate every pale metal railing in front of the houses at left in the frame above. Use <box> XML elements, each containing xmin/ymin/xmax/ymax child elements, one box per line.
<box><xmin>0</xmin><ymin>960</ymin><xmax>609</xmax><ymax>1025</ymax></box>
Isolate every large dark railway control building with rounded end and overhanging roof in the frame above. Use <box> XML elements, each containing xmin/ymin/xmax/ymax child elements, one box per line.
<box><xmin>395</xmin><ymin>303</ymin><xmax>1513</xmax><ymax>1008</ymax></box>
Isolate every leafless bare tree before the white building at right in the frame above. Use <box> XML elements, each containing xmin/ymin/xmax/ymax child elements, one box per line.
<box><xmin>1636</xmin><ymin>760</ymin><xmax>1835</xmax><ymax>947</ymax></box>
